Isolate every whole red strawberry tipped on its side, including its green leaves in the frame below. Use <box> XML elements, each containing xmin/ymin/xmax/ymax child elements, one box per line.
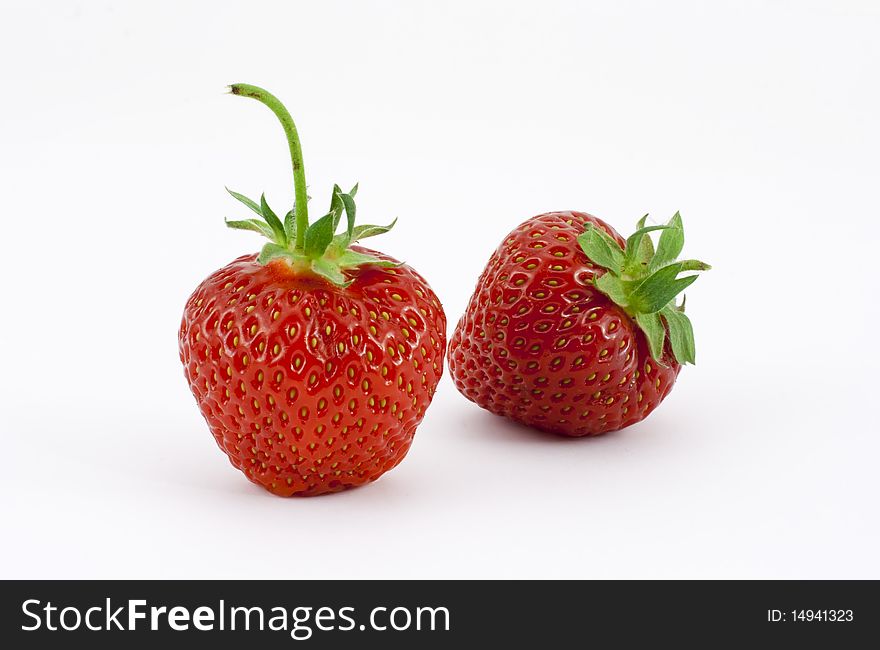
<box><xmin>449</xmin><ymin>212</ymin><xmax>709</xmax><ymax>436</ymax></box>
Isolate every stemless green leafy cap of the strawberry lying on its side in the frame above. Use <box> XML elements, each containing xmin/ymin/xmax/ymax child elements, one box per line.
<box><xmin>578</xmin><ymin>212</ymin><xmax>711</xmax><ymax>364</ymax></box>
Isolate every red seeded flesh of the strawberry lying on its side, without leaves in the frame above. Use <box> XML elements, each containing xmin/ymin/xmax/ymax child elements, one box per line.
<box><xmin>449</xmin><ymin>212</ymin><xmax>681</xmax><ymax>436</ymax></box>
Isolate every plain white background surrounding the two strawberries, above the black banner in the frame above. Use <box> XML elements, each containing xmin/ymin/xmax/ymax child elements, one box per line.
<box><xmin>0</xmin><ymin>0</ymin><xmax>880</xmax><ymax>578</ymax></box>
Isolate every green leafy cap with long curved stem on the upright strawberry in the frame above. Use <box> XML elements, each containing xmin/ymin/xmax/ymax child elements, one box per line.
<box><xmin>226</xmin><ymin>84</ymin><xmax>397</xmax><ymax>286</ymax></box>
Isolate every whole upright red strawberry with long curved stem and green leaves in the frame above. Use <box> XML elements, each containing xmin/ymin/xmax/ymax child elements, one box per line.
<box><xmin>179</xmin><ymin>84</ymin><xmax>446</xmax><ymax>496</ymax></box>
